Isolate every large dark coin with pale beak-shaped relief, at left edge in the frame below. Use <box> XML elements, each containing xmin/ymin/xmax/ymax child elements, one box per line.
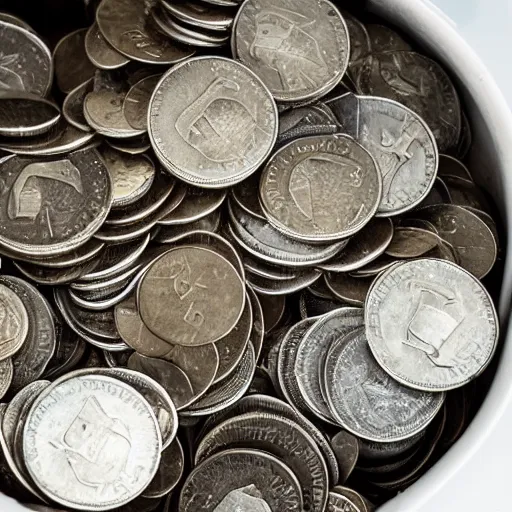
<box><xmin>0</xmin><ymin>148</ymin><xmax>112</xmax><ymax>256</ymax></box>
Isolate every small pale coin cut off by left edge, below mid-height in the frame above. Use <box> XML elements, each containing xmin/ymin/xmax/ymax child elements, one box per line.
<box><xmin>0</xmin><ymin>282</ymin><xmax>29</xmax><ymax>362</ymax></box>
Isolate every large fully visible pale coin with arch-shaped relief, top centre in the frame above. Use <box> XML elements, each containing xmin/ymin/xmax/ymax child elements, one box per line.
<box><xmin>148</xmin><ymin>57</ymin><xmax>277</xmax><ymax>188</ymax></box>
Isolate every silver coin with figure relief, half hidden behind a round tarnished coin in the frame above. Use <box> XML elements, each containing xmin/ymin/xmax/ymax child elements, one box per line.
<box><xmin>327</xmin><ymin>94</ymin><xmax>438</xmax><ymax>216</ymax></box>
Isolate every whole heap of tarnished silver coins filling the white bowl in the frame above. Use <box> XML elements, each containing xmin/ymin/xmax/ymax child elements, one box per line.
<box><xmin>0</xmin><ymin>0</ymin><xmax>501</xmax><ymax>512</ymax></box>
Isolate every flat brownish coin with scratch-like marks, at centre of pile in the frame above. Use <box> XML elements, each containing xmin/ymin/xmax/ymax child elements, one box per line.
<box><xmin>137</xmin><ymin>247</ymin><xmax>245</xmax><ymax>346</ymax></box>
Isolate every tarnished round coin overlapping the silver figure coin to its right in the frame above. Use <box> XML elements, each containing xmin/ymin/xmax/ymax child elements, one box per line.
<box><xmin>260</xmin><ymin>136</ymin><xmax>382</xmax><ymax>242</ymax></box>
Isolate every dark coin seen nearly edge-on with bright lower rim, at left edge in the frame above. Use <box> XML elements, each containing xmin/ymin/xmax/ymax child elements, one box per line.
<box><xmin>0</xmin><ymin>91</ymin><xmax>61</xmax><ymax>137</ymax></box>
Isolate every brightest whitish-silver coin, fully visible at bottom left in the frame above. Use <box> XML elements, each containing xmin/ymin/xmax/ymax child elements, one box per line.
<box><xmin>23</xmin><ymin>375</ymin><xmax>162</xmax><ymax>510</ymax></box>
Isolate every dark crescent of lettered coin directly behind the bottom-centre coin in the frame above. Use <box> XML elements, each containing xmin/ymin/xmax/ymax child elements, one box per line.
<box><xmin>195</xmin><ymin>412</ymin><xmax>328</xmax><ymax>511</ymax></box>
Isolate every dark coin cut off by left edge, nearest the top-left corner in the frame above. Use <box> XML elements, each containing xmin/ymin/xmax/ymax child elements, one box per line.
<box><xmin>0</xmin><ymin>20</ymin><xmax>53</xmax><ymax>97</ymax></box>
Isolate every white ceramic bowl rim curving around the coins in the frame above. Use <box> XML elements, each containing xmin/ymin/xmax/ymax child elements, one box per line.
<box><xmin>0</xmin><ymin>0</ymin><xmax>512</xmax><ymax>512</ymax></box>
